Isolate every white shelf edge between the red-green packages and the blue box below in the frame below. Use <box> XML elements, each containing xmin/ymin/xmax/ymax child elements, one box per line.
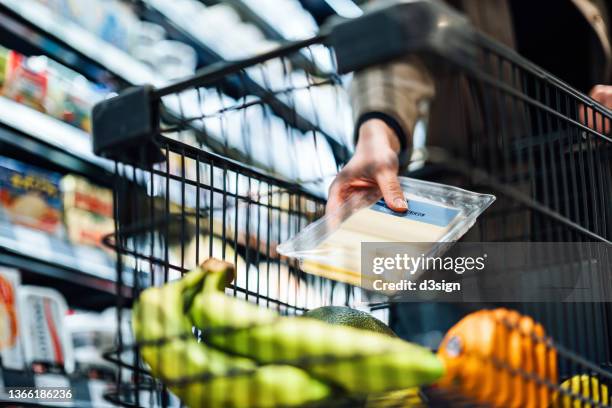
<box><xmin>0</xmin><ymin>96</ymin><xmax>114</xmax><ymax>182</ymax></box>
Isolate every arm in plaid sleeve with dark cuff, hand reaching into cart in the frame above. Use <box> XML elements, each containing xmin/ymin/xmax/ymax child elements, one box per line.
<box><xmin>327</xmin><ymin>57</ymin><xmax>435</xmax><ymax>212</ymax></box>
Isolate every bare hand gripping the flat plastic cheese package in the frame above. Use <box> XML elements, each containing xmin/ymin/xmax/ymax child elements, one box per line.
<box><xmin>325</xmin><ymin>119</ymin><xmax>408</xmax><ymax>214</ymax></box>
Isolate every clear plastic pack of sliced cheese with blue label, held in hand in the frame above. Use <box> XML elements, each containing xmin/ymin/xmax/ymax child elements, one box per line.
<box><xmin>278</xmin><ymin>177</ymin><xmax>495</xmax><ymax>286</ymax></box>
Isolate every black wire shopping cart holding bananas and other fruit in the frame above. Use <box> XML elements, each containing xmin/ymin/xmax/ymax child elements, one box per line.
<box><xmin>94</xmin><ymin>1</ymin><xmax>612</xmax><ymax>407</ymax></box>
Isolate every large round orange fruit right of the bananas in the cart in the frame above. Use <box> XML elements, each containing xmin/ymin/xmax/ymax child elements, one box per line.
<box><xmin>438</xmin><ymin>308</ymin><xmax>557</xmax><ymax>408</ymax></box>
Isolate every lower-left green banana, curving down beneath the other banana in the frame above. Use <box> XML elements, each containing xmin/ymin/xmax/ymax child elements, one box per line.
<box><xmin>132</xmin><ymin>260</ymin><xmax>331</xmax><ymax>408</ymax></box>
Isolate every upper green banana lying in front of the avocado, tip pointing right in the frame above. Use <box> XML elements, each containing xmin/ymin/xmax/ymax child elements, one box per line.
<box><xmin>189</xmin><ymin>258</ymin><xmax>443</xmax><ymax>395</ymax></box>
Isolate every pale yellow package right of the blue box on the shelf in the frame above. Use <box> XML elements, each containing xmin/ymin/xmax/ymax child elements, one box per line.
<box><xmin>60</xmin><ymin>174</ymin><xmax>114</xmax><ymax>249</ymax></box>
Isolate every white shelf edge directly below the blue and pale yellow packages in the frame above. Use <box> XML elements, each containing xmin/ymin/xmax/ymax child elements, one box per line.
<box><xmin>0</xmin><ymin>222</ymin><xmax>130</xmax><ymax>309</ymax></box>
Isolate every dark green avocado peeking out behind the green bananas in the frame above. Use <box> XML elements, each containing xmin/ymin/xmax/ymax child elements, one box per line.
<box><xmin>304</xmin><ymin>306</ymin><xmax>397</xmax><ymax>337</ymax></box>
